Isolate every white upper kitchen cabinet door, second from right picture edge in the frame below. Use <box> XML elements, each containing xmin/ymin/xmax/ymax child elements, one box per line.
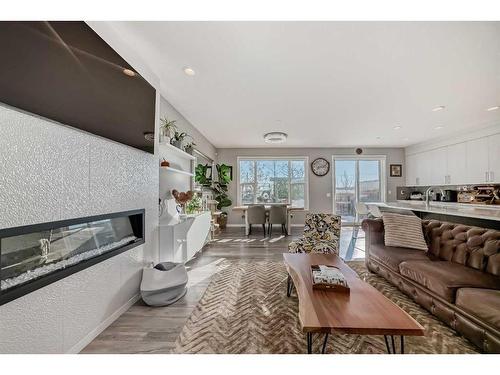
<box><xmin>465</xmin><ymin>138</ymin><xmax>489</xmax><ymax>184</ymax></box>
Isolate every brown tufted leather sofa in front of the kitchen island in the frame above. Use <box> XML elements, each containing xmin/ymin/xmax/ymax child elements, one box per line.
<box><xmin>362</xmin><ymin>219</ymin><xmax>500</xmax><ymax>353</ymax></box>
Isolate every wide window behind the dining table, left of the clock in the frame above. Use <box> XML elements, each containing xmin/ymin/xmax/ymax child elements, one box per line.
<box><xmin>238</xmin><ymin>157</ymin><xmax>309</xmax><ymax>208</ymax></box>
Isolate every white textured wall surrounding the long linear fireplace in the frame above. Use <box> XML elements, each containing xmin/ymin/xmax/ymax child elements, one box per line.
<box><xmin>0</xmin><ymin>105</ymin><xmax>158</xmax><ymax>353</ymax></box>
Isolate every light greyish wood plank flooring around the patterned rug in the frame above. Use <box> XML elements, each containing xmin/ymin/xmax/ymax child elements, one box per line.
<box><xmin>82</xmin><ymin>228</ymin><xmax>365</xmax><ymax>353</ymax></box>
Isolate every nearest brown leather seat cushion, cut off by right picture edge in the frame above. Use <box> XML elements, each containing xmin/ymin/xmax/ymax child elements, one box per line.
<box><xmin>456</xmin><ymin>288</ymin><xmax>500</xmax><ymax>329</ymax></box>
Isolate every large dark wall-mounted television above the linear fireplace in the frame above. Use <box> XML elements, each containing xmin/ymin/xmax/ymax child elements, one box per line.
<box><xmin>0</xmin><ymin>22</ymin><xmax>155</xmax><ymax>152</ymax></box>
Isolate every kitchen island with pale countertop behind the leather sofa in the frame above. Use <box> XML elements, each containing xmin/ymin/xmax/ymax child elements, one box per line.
<box><xmin>367</xmin><ymin>201</ymin><xmax>500</xmax><ymax>229</ymax></box>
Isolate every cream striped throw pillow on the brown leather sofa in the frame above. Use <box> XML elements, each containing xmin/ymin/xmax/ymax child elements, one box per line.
<box><xmin>382</xmin><ymin>212</ymin><xmax>428</xmax><ymax>251</ymax></box>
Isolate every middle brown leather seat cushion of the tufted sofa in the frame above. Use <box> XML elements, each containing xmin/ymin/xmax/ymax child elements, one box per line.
<box><xmin>399</xmin><ymin>260</ymin><xmax>500</xmax><ymax>303</ymax></box>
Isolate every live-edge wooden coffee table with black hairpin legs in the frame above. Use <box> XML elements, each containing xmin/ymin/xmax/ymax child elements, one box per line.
<box><xmin>283</xmin><ymin>254</ymin><xmax>424</xmax><ymax>354</ymax></box>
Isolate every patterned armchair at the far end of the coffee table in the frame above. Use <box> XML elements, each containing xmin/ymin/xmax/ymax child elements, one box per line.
<box><xmin>288</xmin><ymin>214</ymin><xmax>340</xmax><ymax>254</ymax></box>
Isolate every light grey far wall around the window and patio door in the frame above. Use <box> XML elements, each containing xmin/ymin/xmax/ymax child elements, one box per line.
<box><xmin>217</xmin><ymin>148</ymin><xmax>405</xmax><ymax>225</ymax></box>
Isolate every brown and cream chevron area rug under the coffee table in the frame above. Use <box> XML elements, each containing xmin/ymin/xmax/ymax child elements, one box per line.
<box><xmin>173</xmin><ymin>260</ymin><xmax>477</xmax><ymax>354</ymax></box>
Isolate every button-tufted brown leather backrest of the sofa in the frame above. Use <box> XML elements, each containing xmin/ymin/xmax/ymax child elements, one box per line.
<box><xmin>422</xmin><ymin>220</ymin><xmax>500</xmax><ymax>276</ymax></box>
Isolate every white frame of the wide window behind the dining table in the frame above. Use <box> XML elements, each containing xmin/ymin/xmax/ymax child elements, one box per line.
<box><xmin>236</xmin><ymin>156</ymin><xmax>309</xmax><ymax>210</ymax></box>
